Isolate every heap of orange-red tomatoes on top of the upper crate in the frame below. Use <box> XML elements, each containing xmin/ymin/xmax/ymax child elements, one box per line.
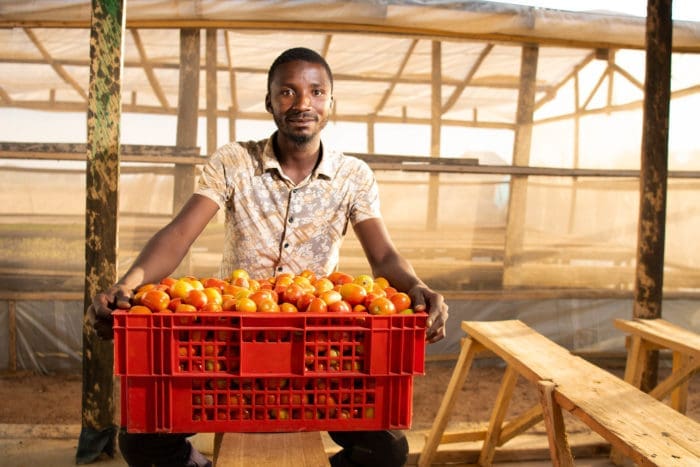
<box><xmin>129</xmin><ymin>269</ymin><xmax>416</xmax><ymax>315</ymax></box>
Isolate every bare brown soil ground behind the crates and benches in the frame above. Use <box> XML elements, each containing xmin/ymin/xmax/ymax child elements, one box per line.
<box><xmin>0</xmin><ymin>360</ymin><xmax>700</xmax><ymax>467</ymax></box>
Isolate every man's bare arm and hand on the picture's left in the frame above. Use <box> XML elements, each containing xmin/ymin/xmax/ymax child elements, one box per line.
<box><xmin>88</xmin><ymin>194</ymin><xmax>219</xmax><ymax>338</ymax></box>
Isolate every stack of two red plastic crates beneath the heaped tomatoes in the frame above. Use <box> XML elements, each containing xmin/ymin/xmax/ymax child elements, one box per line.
<box><xmin>114</xmin><ymin>311</ymin><xmax>427</xmax><ymax>432</ymax></box>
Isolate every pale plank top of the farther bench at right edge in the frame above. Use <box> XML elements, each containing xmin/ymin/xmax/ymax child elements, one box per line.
<box><xmin>614</xmin><ymin>319</ymin><xmax>700</xmax><ymax>359</ymax></box>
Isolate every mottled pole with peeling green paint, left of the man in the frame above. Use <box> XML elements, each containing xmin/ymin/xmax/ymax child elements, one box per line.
<box><xmin>76</xmin><ymin>0</ymin><xmax>126</xmax><ymax>464</ymax></box>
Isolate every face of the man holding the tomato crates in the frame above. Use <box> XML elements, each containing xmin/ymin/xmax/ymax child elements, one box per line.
<box><xmin>265</xmin><ymin>60</ymin><xmax>333</xmax><ymax>144</ymax></box>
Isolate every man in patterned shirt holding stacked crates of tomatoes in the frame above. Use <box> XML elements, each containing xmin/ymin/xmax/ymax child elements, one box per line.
<box><xmin>89</xmin><ymin>48</ymin><xmax>447</xmax><ymax>467</ymax></box>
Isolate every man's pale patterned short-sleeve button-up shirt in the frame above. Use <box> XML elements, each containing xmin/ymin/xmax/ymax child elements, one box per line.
<box><xmin>196</xmin><ymin>138</ymin><xmax>380</xmax><ymax>278</ymax></box>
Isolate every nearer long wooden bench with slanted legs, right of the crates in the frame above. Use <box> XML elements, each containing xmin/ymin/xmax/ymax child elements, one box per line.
<box><xmin>418</xmin><ymin>320</ymin><xmax>700</xmax><ymax>466</ymax></box>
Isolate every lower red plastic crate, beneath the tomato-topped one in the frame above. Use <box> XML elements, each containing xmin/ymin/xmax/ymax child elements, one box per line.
<box><xmin>121</xmin><ymin>375</ymin><xmax>413</xmax><ymax>433</ymax></box>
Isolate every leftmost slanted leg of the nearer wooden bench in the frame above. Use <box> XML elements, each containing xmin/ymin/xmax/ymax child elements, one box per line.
<box><xmin>418</xmin><ymin>338</ymin><xmax>484</xmax><ymax>467</ymax></box>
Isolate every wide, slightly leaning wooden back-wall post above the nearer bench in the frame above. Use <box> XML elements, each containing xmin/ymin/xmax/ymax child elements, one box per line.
<box><xmin>503</xmin><ymin>45</ymin><xmax>539</xmax><ymax>287</ymax></box>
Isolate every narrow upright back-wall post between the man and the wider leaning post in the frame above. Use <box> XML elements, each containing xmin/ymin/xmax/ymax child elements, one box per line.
<box><xmin>426</xmin><ymin>41</ymin><xmax>442</xmax><ymax>230</ymax></box>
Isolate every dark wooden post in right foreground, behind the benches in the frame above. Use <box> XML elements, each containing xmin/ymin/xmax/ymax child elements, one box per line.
<box><xmin>633</xmin><ymin>0</ymin><xmax>673</xmax><ymax>391</ymax></box>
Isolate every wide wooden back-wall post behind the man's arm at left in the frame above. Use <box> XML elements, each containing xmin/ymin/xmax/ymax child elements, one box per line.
<box><xmin>173</xmin><ymin>28</ymin><xmax>200</xmax><ymax>275</ymax></box>
